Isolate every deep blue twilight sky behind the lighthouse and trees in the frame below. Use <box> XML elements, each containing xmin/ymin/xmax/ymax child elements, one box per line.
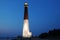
<box><xmin>0</xmin><ymin>0</ymin><xmax>60</xmax><ymax>37</ymax></box>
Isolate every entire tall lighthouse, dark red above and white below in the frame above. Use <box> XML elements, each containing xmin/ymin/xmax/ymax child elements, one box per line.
<box><xmin>22</xmin><ymin>2</ymin><xmax>32</xmax><ymax>38</ymax></box>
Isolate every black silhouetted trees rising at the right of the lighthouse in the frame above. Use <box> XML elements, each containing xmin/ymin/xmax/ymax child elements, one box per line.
<box><xmin>39</xmin><ymin>29</ymin><xmax>60</xmax><ymax>38</ymax></box>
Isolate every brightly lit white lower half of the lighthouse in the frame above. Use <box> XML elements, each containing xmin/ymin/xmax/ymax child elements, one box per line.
<box><xmin>23</xmin><ymin>19</ymin><xmax>32</xmax><ymax>38</ymax></box>
